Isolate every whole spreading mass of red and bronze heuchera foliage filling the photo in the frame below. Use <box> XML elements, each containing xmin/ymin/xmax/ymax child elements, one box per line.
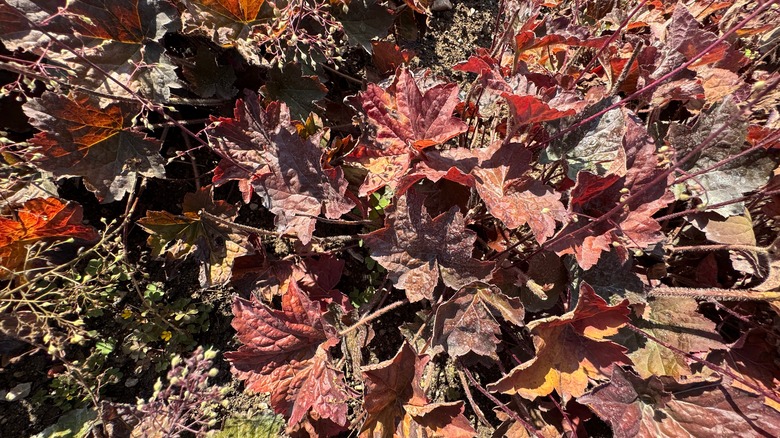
<box><xmin>0</xmin><ymin>0</ymin><xmax>780</xmax><ymax>437</ymax></box>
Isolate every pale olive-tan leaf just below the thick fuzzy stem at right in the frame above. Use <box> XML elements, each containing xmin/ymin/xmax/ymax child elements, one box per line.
<box><xmin>619</xmin><ymin>298</ymin><xmax>725</xmax><ymax>380</ymax></box>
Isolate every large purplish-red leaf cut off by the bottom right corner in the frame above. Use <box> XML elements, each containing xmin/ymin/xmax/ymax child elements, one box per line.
<box><xmin>578</xmin><ymin>367</ymin><xmax>780</xmax><ymax>438</ymax></box>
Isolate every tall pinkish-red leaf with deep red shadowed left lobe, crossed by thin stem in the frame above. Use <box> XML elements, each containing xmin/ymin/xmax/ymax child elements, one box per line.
<box><xmin>548</xmin><ymin>113</ymin><xmax>674</xmax><ymax>270</ymax></box>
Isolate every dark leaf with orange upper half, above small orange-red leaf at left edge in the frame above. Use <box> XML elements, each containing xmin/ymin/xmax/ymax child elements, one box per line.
<box><xmin>24</xmin><ymin>92</ymin><xmax>165</xmax><ymax>202</ymax></box>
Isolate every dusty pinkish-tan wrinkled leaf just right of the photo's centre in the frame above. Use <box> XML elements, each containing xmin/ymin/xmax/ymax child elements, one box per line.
<box><xmin>472</xmin><ymin>144</ymin><xmax>567</xmax><ymax>243</ymax></box>
